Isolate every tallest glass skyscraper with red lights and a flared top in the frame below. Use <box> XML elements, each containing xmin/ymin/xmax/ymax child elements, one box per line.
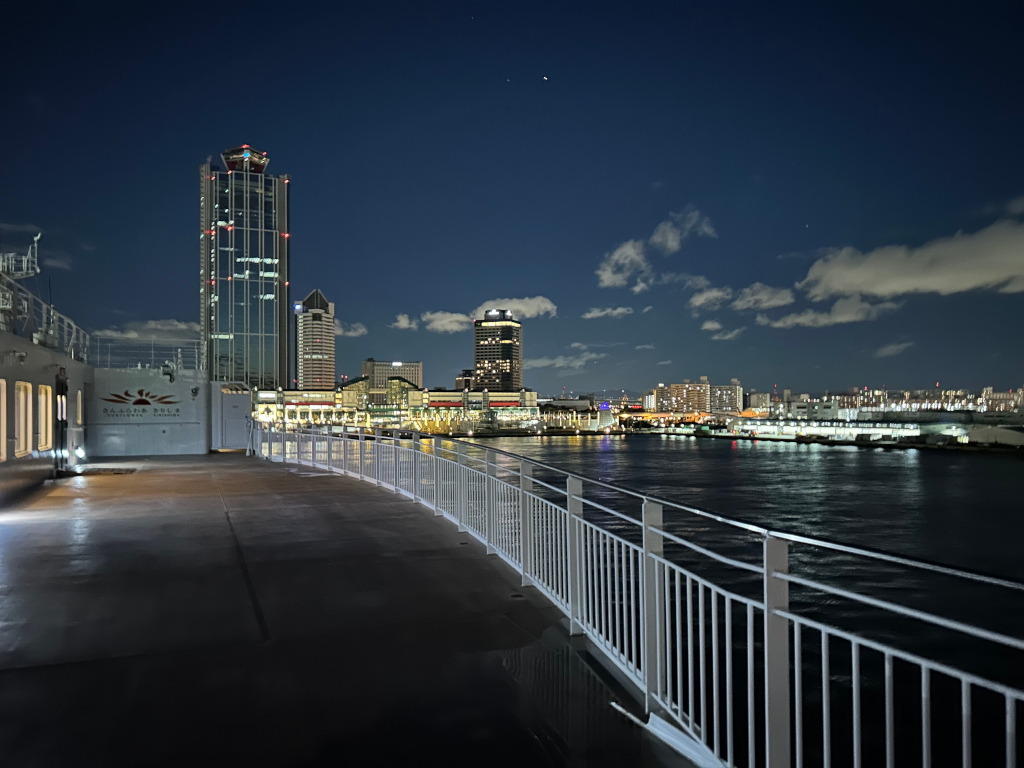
<box><xmin>199</xmin><ymin>144</ymin><xmax>291</xmax><ymax>389</ymax></box>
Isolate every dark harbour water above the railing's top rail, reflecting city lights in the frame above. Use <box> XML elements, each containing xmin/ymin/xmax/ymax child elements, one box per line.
<box><xmin>480</xmin><ymin>435</ymin><xmax>1024</xmax><ymax>580</ymax></box>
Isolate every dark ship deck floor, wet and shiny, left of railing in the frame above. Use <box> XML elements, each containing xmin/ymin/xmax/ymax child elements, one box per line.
<box><xmin>0</xmin><ymin>455</ymin><xmax>688</xmax><ymax>767</ymax></box>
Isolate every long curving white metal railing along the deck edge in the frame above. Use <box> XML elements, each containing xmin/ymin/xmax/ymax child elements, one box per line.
<box><xmin>253</xmin><ymin>428</ymin><xmax>1024</xmax><ymax>768</ymax></box>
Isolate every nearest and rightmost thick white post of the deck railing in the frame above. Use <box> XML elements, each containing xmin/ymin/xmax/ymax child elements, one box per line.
<box><xmin>764</xmin><ymin>536</ymin><xmax>790</xmax><ymax>768</ymax></box>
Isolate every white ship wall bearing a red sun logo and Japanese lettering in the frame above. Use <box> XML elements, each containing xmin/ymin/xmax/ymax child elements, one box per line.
<box><xmin>86</xmin><ymin>369</ymin><xmax>210</xmax><ymax>459</ymax></box>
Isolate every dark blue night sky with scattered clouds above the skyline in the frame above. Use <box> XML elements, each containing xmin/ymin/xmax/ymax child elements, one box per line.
<box><xmin>0</xmin><ymin>2</ymin><xmax>1024</xmax><ymax>392</ymax></box>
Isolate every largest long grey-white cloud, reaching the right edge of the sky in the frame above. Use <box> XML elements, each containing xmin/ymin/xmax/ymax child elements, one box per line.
<box><xmin>797</xmin><ymin>219</ymin><xmax>1024</xmax><ymax>301</ymax></box>
